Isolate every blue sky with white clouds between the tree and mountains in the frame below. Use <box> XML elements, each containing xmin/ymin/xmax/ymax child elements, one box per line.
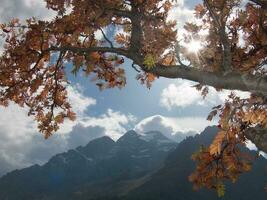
<box><xmin>0</xmin><ymin>0</ymin><xmax>252</xmax><ymax>176</ymax></box>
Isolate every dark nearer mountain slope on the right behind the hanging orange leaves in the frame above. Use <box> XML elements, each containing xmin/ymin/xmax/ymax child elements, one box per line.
<box><xmin>123</xmin><ymin>127</ymin><xmax>267</xmax><ymax>200</ymax></box>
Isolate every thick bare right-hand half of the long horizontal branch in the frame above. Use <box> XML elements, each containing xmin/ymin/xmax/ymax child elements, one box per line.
<box><xmin>149</xmin><ymin>65</ymin><xmax>267</xmax><ymax>95</ymax></box>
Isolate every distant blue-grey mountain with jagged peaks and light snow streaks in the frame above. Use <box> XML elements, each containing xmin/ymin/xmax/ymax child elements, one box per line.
<box><xmin>0</xmin><ymin>131</ymin><xmax>177</xmax><ymax>200</ymax></box>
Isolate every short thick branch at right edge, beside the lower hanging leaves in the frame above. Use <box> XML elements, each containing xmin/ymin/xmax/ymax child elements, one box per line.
<box><xmin>244</xmin><ymin>126</ymin><xmax>267</xmax><ymax>153</ymax></box>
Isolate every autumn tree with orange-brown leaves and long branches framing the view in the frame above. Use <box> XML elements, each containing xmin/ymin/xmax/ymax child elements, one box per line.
<box><xmin>0</xmin><ymin>0</ymin><xmax>267</xmax><ymax>195</ymax></box>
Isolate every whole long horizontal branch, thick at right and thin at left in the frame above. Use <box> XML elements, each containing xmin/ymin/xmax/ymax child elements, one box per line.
<box><xmin>47</xmin><ymin>46</ymin><xmax>267</xmax><ymax>95</ymax></box>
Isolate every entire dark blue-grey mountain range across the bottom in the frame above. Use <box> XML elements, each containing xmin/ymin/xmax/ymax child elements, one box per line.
<box><xmin>0</xmin><ymin>127</ymin><xmax>267</xmax><ymax>200</ymax></box>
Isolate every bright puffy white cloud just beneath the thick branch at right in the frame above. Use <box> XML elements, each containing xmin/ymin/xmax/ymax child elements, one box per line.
<box><xmin>160</xmin><ymin>80</ymin><xmax>249</xmax><ymax>110</ymax></box>
